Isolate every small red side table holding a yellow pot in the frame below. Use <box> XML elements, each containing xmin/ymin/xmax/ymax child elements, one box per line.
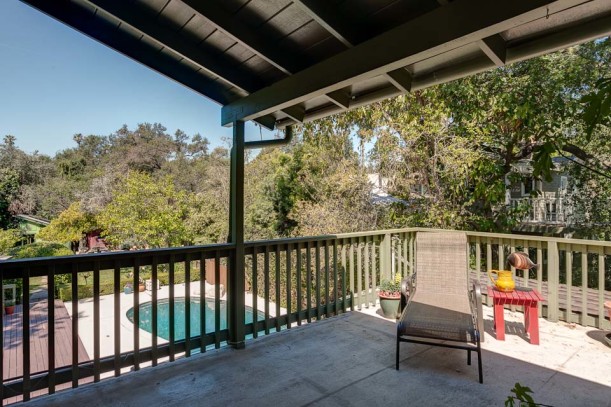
<box><xmin>488</xmin><ymin>286</ymin><xmax>544</xmax><ymax>345</ymax></box>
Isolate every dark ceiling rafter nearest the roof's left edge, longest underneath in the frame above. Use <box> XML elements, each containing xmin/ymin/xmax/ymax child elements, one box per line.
<box><xmin>86</xmin><ymin>0</ymin><xmax>267</xmax><ymax>93</ymax></box>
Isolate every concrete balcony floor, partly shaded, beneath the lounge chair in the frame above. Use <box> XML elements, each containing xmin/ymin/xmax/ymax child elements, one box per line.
<box><xmin>21</xmin><ymin>308</ymin><xmax>611</xmax><ymax>407</ymax></box>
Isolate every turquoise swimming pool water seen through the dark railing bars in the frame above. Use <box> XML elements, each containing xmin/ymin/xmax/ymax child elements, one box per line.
<box><xmin>126</xmin><ymin>297</ymin><xmax>265</xmax><ymax>341</ymax></box>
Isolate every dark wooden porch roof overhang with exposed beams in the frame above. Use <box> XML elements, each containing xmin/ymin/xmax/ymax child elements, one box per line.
<box><xmin>22</xmin><ymin>0</ymin><xmax>611</xmax><ymax>128</ymax></box>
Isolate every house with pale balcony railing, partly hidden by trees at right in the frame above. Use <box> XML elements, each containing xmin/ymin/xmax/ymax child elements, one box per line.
<box><xmin>506</xmin><ymin>157</ymin><xmax>573</xmax><ymax>237</ymax></box>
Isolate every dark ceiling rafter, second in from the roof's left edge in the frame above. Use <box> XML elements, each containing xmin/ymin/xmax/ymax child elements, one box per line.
<box><xmin>182</xmin><ymin>0</ymin><xmax>306</xmax><ymax>74</ymax></box>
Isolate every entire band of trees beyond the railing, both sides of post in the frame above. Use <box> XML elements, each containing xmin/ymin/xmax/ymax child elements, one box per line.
<box><xmin>0</xmin><ymin>38</ymin><xmax>611</xmax><ymax>255</ymax></box>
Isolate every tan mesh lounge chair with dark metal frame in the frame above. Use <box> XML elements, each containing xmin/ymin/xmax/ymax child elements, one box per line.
<box><xmin>396</xmin><ymin>232</ymin><xmax>483</xmax><ymax>383</ymax></box>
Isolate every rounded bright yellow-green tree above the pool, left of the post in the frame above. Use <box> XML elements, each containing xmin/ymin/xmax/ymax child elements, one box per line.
<box><xmin>98</xmin><ymin>171</ymin><xmax>193</xmax><ymax>247</ymax></box>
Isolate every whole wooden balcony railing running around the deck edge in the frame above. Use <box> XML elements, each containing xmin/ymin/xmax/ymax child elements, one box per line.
<box><xmin>0</xmin><ymin>228</ymin><xmax>611</xmax><ymax>400</ymax></box>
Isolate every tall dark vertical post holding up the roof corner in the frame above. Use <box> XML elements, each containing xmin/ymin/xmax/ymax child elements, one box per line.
<box><xmin>228</xmin><ymin>120</ymin><xmax>246</xmax><ymax>349</ymax></box>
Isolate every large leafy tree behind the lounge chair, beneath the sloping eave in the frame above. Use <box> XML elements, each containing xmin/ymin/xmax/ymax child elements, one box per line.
<box><xmin>300</xmin><ymin>39</ymin><xmax>611</xmax><ymax>236</ymax></box>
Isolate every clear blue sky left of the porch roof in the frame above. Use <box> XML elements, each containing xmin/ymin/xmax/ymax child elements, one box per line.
<box><xmin>0</xmin><ymin>0</ymin><xmax>244</xmax><ymax>155</ymax></box>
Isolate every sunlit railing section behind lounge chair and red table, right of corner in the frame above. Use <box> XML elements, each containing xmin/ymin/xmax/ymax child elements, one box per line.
<box><xmin>392</xmin><ymin>229</ymin><xmax>611</xmax><ymax>329</ymax></box>
